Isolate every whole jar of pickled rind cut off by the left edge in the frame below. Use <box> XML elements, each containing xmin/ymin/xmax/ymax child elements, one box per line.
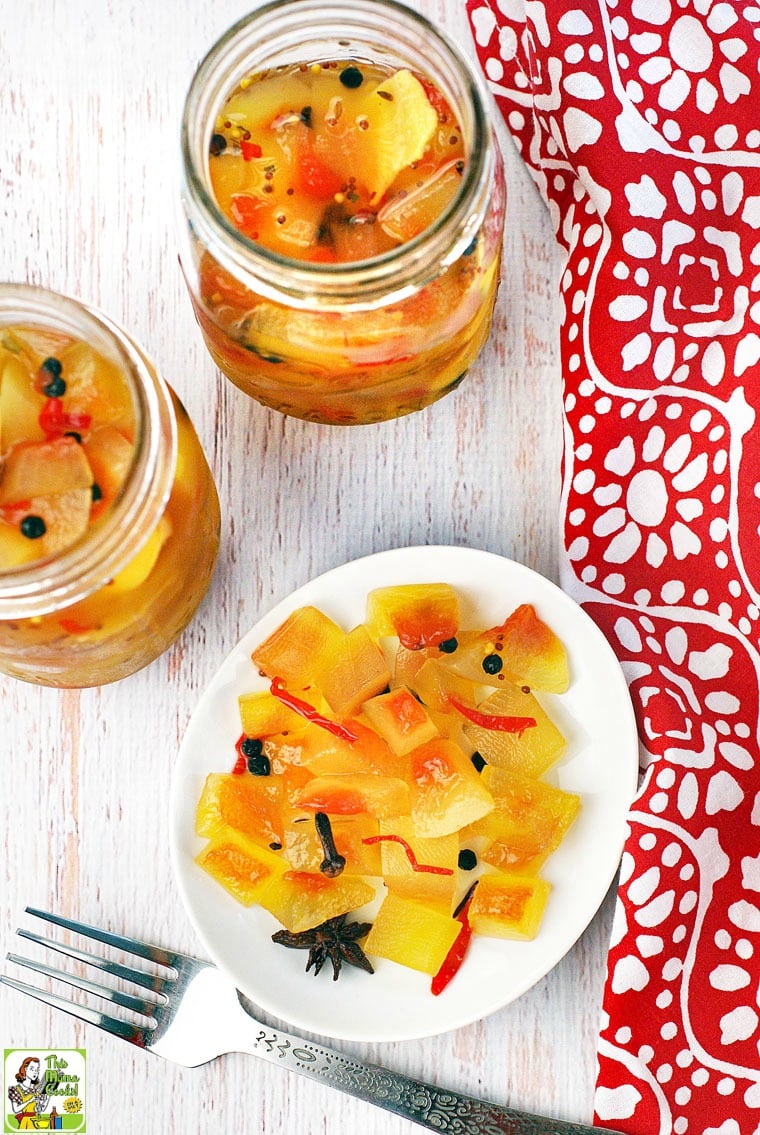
<box><xmin>0</xmin><ymin>284</ymin><xmax>219</xmax><ymax>687</ymax></box>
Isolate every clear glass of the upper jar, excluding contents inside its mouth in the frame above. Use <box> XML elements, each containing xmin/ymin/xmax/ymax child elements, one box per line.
<box><xmin>180</xmin><ymin>0</ymin><xmax>506</xmax><ymax>424</ymax></box>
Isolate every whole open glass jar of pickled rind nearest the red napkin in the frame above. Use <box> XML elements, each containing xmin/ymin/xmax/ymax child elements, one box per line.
<box><xmin>181</xmin><ymin>0</ymin><xmax>505</xmax><ymax>423</ymax></box>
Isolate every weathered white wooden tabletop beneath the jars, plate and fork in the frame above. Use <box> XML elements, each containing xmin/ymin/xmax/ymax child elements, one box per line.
<box><xmin>0</xmin><ymin>0</ymin><xmax>611</xmax><ymax>1135</ymax></box>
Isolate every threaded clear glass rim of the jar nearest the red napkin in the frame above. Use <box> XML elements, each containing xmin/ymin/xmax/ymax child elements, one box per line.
<box><xmin>180</xmin><ymin>0</ymin><xmax>495</xmax><ymax>310</ymax></box>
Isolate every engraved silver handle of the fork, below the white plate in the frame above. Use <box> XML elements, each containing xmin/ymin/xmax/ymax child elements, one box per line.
<box><xmin>230</xmin><ymin>1015</ymin><xmax>620</xmax><ymax>1135</ymax></box>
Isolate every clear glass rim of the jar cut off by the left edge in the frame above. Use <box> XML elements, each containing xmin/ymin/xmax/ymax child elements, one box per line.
<box><xmin>0</xmin><ymin>283</ymin><xmax>177</xmax><ymax>619</ymax></box>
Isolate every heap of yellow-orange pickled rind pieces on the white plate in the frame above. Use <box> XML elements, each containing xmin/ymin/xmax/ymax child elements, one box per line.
<box><xmin>193</xmin><ymin>583</ymin><xmax>581</xmax><ymax>974</ymax></box>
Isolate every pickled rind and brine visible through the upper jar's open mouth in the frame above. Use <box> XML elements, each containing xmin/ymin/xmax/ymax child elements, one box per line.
<box><xmin>209</xmin><ymin>60</ymin><xmax>474</xmax><ymax>263</ymax></box>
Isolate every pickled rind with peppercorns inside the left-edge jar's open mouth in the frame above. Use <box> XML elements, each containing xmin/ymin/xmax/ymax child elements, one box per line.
<box><xmin>0</xmin><ymin>327</ymin><xmax>144</xmax><ymax>576</ymax></box>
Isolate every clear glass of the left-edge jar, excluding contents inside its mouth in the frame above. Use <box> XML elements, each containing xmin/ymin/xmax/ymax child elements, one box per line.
<box><xmin>0</xmin><ymin>284</ymin><xmax>220</xmax><ymax>687</ymax></box>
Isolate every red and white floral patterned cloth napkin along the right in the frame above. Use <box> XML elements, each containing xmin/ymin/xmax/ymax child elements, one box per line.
<box><xmin>466</xmin><ymin>0</ymin><xmax>760</xmax><ymax>1135</ymax></box>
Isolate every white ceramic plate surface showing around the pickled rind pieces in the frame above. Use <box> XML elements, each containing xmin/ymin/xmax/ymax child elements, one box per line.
<box><xmin>170</xmin><ymin>547</ymin><xmax>637</xmax><ymax>1041</ymax></box>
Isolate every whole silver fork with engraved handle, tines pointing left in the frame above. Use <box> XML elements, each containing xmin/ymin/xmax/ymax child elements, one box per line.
<box><xmin>0</xmin><ymin>907</ymin><xmax>619</xmax><ymax>1135</ymax></box>
